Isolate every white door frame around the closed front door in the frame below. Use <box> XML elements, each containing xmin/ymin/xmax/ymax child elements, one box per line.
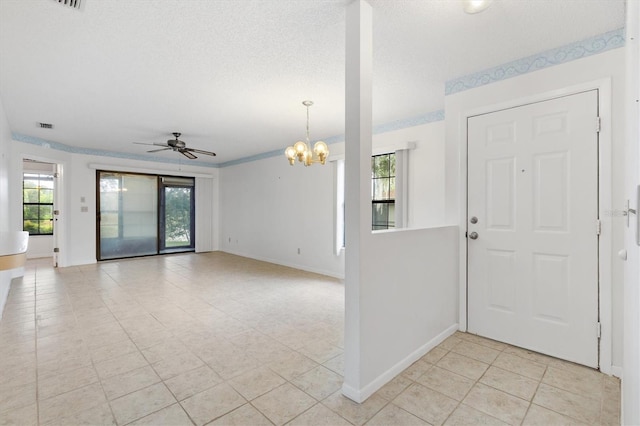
<box><xmin>458</xmin><ymin>78</ymin><xmax>613</xmax><ymax>374</ymax></box>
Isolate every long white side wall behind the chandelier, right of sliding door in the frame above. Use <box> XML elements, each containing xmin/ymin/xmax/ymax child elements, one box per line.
<box><xmin>220</xmin><ymin>155</ymin><xmax>344</xmax><ymax>277</ymax></box>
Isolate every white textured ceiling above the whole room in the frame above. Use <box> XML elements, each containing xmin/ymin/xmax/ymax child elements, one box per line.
<box><xmin>0</xmin><ymin>0</ymin><xmax>624</xmax><ymax>163</ymax></box>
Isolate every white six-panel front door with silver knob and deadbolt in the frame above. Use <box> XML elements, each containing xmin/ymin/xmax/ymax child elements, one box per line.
<box><xmin>467</xmin><ymin>90</ymin><xmax>599</xmax><ymax>367</ymax></box>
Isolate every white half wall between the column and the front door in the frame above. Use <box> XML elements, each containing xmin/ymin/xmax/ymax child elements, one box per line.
<box><xmin>343</xmin><ymin>226</ymin><xmax>459</xmax><ymax>400</ymax></box>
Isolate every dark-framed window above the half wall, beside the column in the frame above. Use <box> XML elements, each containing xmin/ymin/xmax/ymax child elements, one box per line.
<box><xmin>371</xmin><ymin>153</ymin><xmax>396</xmax><ymax>231</ymax></box>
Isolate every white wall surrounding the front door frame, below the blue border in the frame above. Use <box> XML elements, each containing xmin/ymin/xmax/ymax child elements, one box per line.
<box><xmin>445</xmin><ymin>49</ymin><xmax>625</xmax><ymax>369</ymax></box>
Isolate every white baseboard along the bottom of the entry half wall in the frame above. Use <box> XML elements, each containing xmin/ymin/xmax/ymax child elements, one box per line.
<box><xmin>342</xmin><ymin>324</ymin><xmax>458</xmax><ymax>404</ymax></box>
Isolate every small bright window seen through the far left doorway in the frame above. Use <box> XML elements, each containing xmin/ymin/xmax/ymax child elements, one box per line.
<box><xmin>22</xmin><ymin>173</ymin><xmax>53</xmax><ymax>235</ymax></box>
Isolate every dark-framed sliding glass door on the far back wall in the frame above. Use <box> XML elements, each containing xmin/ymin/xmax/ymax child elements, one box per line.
<box><xmin>96</xmin><ymin>171</ymin><xmax>195</xmax><ymax>260</ymax></box>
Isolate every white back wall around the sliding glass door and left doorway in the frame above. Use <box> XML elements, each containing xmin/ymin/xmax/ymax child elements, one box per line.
<box><xmin>10</xmin><ymin>141</ymin><xmax>218</xmax><ymax>266</ymax></box>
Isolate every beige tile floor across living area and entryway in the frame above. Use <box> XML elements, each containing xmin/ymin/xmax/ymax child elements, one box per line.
<box><xmin>0</xmin><ymin>253</ymin><xmax>620</xmax><ymax>426</ymax></box>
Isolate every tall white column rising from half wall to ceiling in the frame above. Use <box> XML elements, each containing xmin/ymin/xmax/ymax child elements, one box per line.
<box><xmin>342</xmin><ymin>0</ymin><xmax>373</xmax><ymax>402</ymax></box>
